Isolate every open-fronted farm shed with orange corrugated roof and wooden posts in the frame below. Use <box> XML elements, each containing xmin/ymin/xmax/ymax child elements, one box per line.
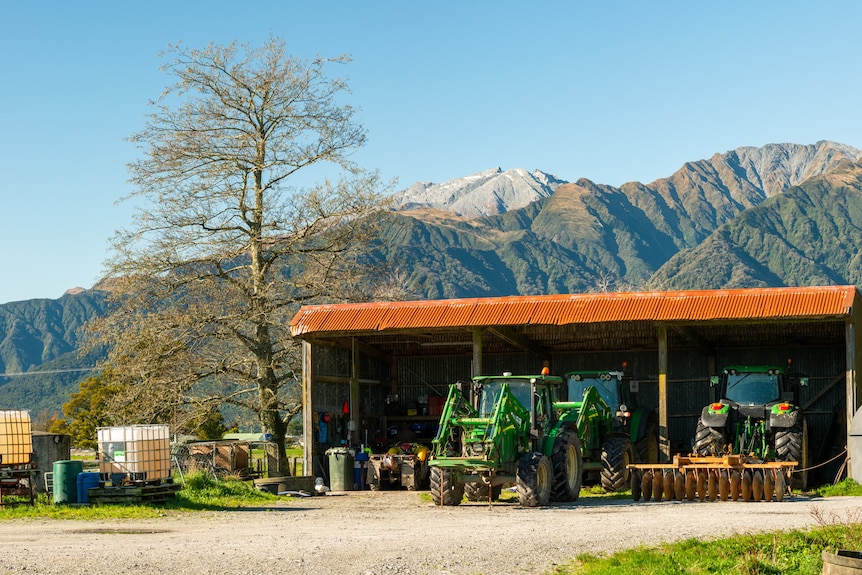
<box><xmin>290</xmin><ymin>286</ymin><xmax>862</xmax><ymax>479</ymax></box>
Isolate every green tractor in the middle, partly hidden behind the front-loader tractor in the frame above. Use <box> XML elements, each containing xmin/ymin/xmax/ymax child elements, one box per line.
<box><xmin>566</xmin><ymin>371</ymin><xmax>659</xmax><ymax>492</ymax></box>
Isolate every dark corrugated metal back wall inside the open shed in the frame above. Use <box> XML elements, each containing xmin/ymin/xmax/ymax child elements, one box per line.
<box><xmin>314</xmin><ymin>338</ymin><xmax>846</xmax><ymax>480</ymax></box>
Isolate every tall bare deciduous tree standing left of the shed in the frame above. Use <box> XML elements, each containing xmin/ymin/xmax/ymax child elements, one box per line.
<box><xmin>91</xmin><ymin>38</ymin><xmax>392</xmax><ymax>474</ymax></box>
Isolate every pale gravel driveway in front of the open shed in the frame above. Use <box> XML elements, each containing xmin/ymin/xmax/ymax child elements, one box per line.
<box><xmin>0</xmin><ymin>491</ymin><xmax>862</xmax><ymax>575</ymax></box>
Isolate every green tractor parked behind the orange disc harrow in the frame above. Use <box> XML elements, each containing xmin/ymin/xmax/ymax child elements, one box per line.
<box><xmin>693</xmin><ymin>365</ymin><xmax>808</xmax><ymax>489</ymax></box>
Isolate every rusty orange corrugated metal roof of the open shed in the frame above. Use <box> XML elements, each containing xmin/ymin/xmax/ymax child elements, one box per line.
<box><xmin>290</xmin><ymin>286</ymin><xmax>860</xmax><ymax>338</ymax></box>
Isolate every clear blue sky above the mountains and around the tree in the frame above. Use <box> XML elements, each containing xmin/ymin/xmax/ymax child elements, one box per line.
<box><xmin>0</xmin><ymin>0</ymin><xmax>862</xmax><ymax>303</ymax></box>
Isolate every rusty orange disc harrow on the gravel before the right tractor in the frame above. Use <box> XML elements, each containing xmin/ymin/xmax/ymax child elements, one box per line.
<box><xmin>629</xmin><ymin>455</ymin><xmax>798</xmax><ymax>501</ymax></box>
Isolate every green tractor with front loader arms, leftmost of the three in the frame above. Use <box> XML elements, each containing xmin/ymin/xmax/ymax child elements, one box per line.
<box><xmin>428</xmin><ymin>370</ymin><xmax>583</xmax><ymax>507</ymax></box>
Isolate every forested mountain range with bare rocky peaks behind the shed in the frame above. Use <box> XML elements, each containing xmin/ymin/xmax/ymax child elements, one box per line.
<box><xmin>5</xmin><ymin>141</ymin><xmax>862</xmax><ymax>413</ymax></box>
